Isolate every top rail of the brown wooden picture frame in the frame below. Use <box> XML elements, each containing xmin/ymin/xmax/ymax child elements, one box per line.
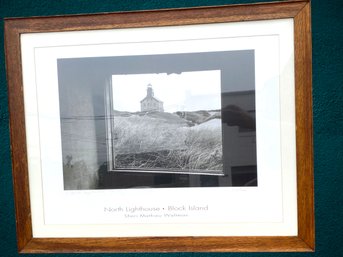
<box><xmin>6</xmin><ymin>1</ymin><xmax>306</xmax><ymax>33</ymax></box>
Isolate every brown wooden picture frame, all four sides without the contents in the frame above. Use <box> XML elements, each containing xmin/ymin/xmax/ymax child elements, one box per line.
<box><xmin>5</xmin><ymin>0</ymin><xmax>315</xmax><ymax>253</ymax></box>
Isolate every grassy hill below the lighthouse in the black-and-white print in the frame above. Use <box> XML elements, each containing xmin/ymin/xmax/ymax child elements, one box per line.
<box><xmin>113</xmin><ymin>111</ymin><xmax>222</xmax><ymax>171</ymax></box>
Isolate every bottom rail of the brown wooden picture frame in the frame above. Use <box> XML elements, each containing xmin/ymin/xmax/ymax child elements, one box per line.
<box><xmin>22</xmin><ymin>237</ymin><xmax>308</xmax><ymax>253</ymax></box>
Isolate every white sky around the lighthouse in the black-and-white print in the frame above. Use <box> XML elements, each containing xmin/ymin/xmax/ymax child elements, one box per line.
<box><xmin>112</xmin><ymin>70</ymin><xmax>221</xmax><ymax>112</ymax></box>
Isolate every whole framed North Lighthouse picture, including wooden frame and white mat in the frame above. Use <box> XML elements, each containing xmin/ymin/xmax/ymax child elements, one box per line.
<box><xmin>5</xmin><ymin>1</ymin><xmax>314</xmax><ymax>253</ymax></box>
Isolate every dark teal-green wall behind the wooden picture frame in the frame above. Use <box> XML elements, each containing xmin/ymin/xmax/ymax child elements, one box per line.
<box><xmin>0</xmin><ymin>0</ymin><xmax>343</xmax><ymax>257</ymax></box>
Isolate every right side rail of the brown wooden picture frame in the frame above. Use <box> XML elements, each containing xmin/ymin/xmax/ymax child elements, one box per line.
<box><xmin>294</xmin><ymin>4</ymin><xmax>315</xmax><ymax>249</ymax></box>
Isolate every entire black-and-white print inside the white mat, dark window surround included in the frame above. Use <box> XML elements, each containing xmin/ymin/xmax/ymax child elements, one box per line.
<box><xmin>58</xmin><ymin>50</ymin><xmax>258</xmax><ymax>190</ymax></box>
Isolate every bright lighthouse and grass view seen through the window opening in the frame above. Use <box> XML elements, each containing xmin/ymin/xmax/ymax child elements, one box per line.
<box><xmin>111</xmin><ymin>71</ymin><xmax>223</xmax><ymax>175</ymax></box>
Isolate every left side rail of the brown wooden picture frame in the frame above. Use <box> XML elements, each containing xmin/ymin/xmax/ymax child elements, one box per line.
<box><xmin>5</xmin><ymin>21</ymin><xmax>32</xmax><ymax>249</ymax></box>
